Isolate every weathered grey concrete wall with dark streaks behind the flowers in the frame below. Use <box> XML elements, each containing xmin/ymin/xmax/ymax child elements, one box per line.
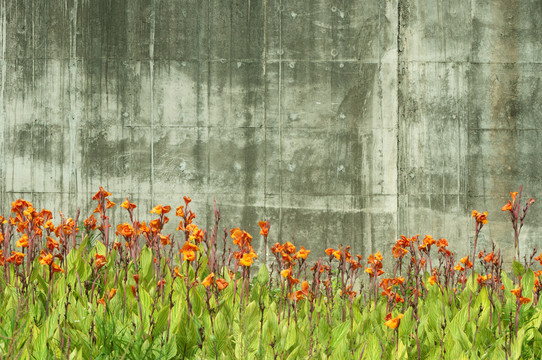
<box><xmin>0</xmin><ymin>0</ymin><xmax>542</xmax><ymax>262</ymax></box>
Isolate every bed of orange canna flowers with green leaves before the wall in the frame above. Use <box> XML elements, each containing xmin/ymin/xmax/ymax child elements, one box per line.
<box><xmin>0</xmin><ymin>188</ymin><xmax>542</xmax><ymax>359</ymax></box>
